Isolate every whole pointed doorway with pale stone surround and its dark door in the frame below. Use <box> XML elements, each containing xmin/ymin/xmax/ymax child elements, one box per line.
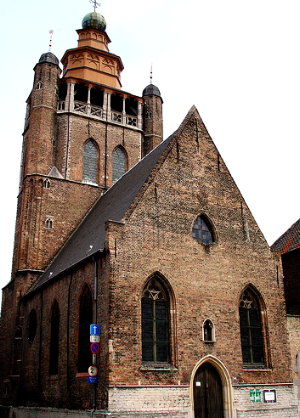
<box><xmin>191</xmin><ymin>355</ymin><xmax>233</xmax><ymax>418</ymax></box>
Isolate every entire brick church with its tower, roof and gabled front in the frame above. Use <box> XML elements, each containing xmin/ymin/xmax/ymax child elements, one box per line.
<box><xmin>0</xmin><ymin>4</ymin><xmax>299</xmax><ymax>418</ymax></box>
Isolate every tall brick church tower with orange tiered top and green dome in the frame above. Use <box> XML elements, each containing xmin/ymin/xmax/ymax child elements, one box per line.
<box><xmin>12</xmin><ymin>6</ymin><xmax>154</xmax><ymax>294</ymax></box>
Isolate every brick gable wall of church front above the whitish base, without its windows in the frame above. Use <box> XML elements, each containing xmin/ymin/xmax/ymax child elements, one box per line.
<box><xmin>106</xmin><ymin>110</ymin><xmax>291</xmax><ymax>385</ymax></box>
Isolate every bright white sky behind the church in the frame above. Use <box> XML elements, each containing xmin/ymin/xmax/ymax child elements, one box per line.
<box><xmin>0</xmin><ymin>0</ymin><xmax>300</xmax><ymax>298</ymax></box>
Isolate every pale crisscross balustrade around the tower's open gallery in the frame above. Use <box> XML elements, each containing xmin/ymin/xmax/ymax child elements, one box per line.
<box><xmin>57</xmin><ymin>100</ymin><xmax>138</xmax><ymax>128</ymax></box>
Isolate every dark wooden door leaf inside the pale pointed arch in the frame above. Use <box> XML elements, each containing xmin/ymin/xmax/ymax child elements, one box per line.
<box><xmin>194</xmin><ymin>363</ymin><xmax>224</xmax><ymax>418</ymax></box>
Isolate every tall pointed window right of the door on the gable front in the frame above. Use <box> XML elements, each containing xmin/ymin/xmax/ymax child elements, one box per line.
<box><xmin>239</xmin><ymin>287</ymin><xmax>265</xmax><ymax>366</ymax></box>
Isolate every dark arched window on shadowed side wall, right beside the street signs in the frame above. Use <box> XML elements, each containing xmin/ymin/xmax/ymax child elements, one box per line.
<box><xmin>78</xmin><ymin>286</ymin><xmax>93</xmax><ymax>372</ymax></box>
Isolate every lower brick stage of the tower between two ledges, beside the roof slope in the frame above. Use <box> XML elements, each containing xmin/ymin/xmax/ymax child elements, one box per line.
<box><xmin>13</xmin><ymin>175</ymin><xmax>100</xmax><ymax>272</ymax></box>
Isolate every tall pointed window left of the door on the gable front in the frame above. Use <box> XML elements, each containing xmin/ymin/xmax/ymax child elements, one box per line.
<box><xmin>142</xmin><ymin>277</ymin><xmax>170</xmax><ymax>363</ymax></box>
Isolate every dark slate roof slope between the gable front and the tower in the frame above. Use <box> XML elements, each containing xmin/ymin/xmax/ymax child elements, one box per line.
<box><xmin>27</xmin><ymin>106</ymin><xmax>199</xmax><ymax>294</ymax></box>
